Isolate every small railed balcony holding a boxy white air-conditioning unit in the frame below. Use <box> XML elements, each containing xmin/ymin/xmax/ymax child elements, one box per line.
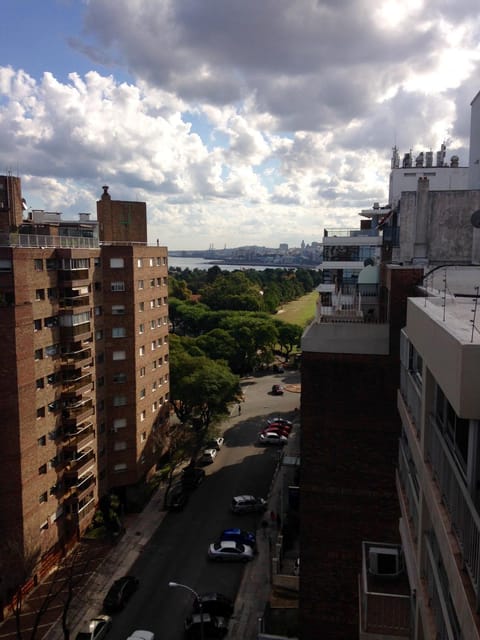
<box><xmin>358</xmin><ymin>542</ymin><xmax>412</xmax><ymax>640</ymax></box>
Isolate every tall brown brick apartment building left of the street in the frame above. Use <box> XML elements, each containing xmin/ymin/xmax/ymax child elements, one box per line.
<box><xmin>0</xmin><ymin>176</ymin><xmax>169</xmax><ymax>611</ymax></box>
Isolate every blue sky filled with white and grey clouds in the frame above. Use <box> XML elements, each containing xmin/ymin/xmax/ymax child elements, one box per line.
<box><xmin>0</xmin><ymin>0</ymin><xmax>480</xmax><ymax>250</ymax></box>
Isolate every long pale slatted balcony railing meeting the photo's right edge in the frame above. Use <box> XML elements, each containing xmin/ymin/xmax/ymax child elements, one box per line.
<box><xmin>426</xmin><ymin>416</ymin><xmax>480</xmax><ymax>605</ymax></box>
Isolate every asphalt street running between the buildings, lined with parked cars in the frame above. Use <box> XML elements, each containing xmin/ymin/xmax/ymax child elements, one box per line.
<box><xmin>0</xmin><ymin>372</ymin><xmax>300</xmax><ymax>640</ymax></box>
